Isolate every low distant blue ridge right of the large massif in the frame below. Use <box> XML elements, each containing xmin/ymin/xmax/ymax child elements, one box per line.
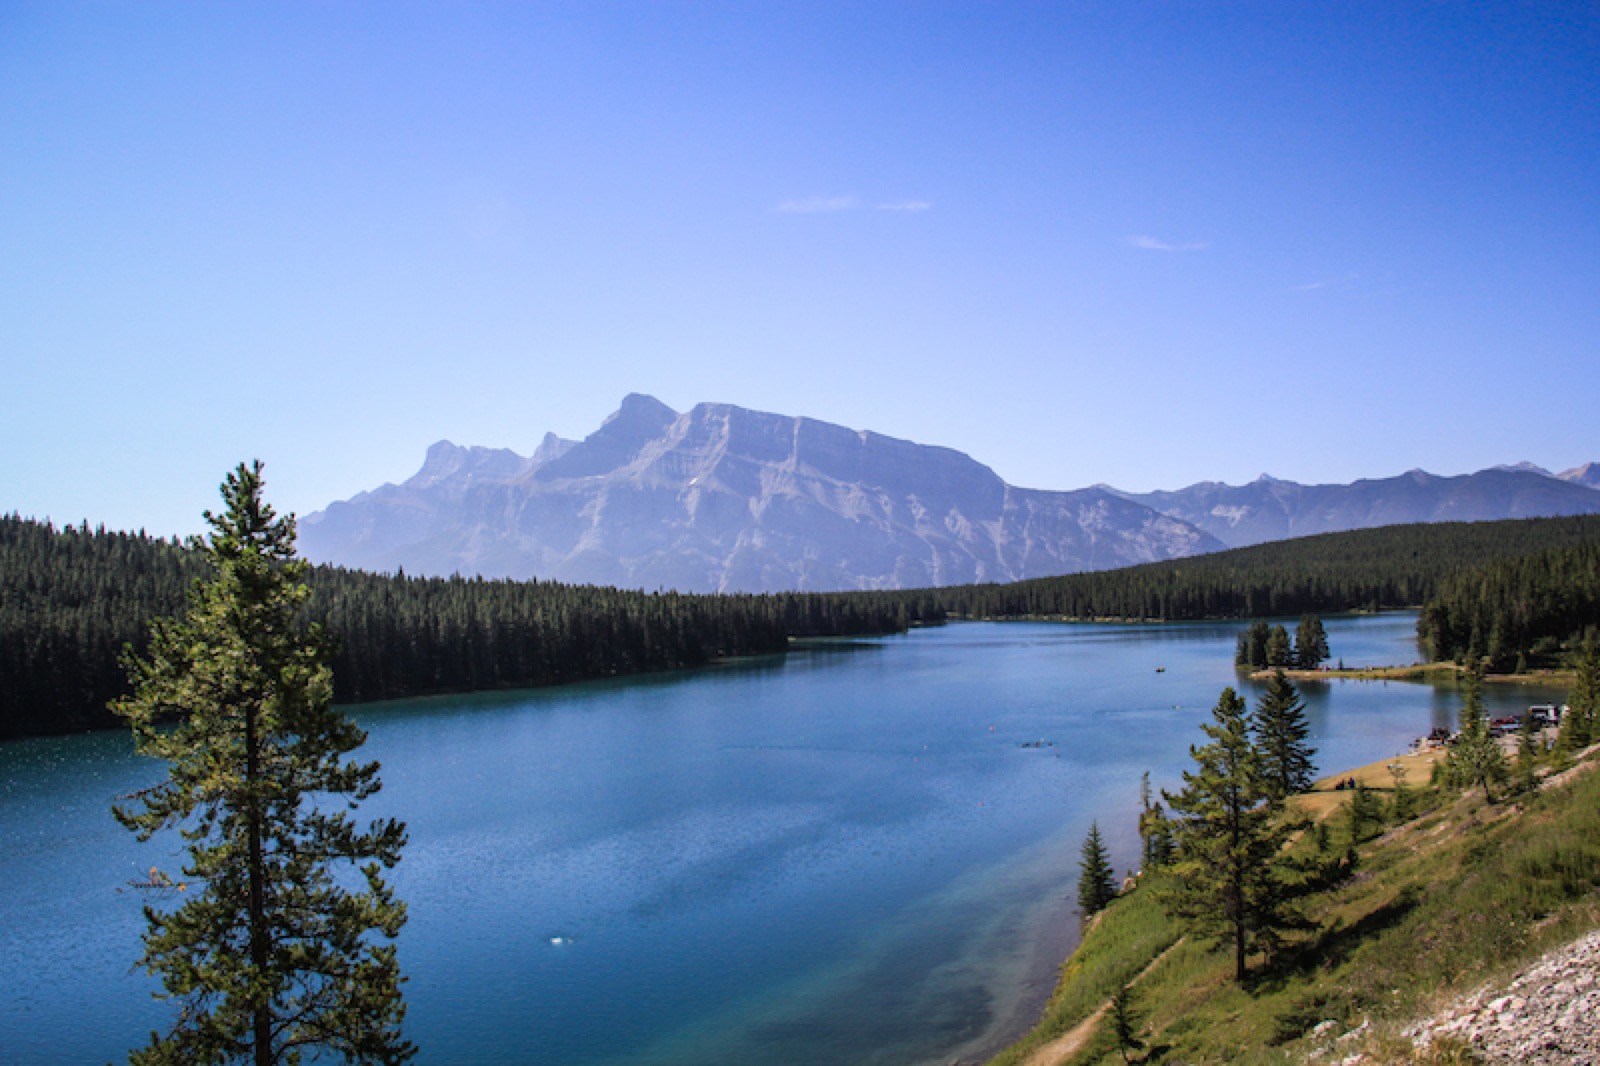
<box><xmin>1112</xmin><ymin>463</ymin><xmax>1600</xmax><ymax>547</ymax></box>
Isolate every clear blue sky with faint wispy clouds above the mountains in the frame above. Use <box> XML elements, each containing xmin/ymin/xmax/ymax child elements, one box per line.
<box><xmin>0</xmin><ymin>0</ymin><xmax>1600</xmax><ymax>535</ymax></box>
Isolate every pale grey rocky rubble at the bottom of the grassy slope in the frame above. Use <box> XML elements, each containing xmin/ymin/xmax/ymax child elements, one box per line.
<box><xmin>1405</xmin><ymin>932</ymin><xmax>1600</xmax><ymax>1066</ymax></box>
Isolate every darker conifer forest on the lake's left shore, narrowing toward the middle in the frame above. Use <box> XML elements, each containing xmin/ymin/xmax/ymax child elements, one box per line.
<box><xmin>0</xmin><ymin>515</ymin><xmax>938</xmax><ymax>738</ymax></box>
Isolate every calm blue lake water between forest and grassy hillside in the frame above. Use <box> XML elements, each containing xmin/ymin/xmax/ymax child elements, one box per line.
<box><xmin>0</xmin><ymin>615</ymin><xmax>1558</xmax><ymax>1066</ymax></box>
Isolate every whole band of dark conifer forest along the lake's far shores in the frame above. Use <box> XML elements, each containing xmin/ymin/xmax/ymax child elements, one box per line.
<box><xmin>0</xmin><ymin>514</ymin><xmax>1600</xmax><ymax>738</ymax></box>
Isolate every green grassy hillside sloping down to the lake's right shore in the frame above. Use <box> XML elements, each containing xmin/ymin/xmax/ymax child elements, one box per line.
<box><xmin>990</xmin><ymin>749</ymin><xmax>1600</xmax><ymax>1066</ymax></box>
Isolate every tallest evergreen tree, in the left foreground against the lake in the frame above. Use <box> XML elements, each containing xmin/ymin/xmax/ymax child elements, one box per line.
<box><xmin>114</xmin><ymin>463</ymin><xmax>416</xmax><ymax>1066</ymax></box>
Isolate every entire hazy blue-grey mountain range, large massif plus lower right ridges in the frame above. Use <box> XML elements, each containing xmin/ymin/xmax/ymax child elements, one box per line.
<box><xmin>299</xmin><ymin>394</ymin><xmax>1600</xmax><ymax>592</ymax></box>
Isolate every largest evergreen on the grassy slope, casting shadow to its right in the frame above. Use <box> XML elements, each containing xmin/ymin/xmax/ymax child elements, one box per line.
<box><xmin>1163</xmin><ymin>688</ymin><xmax>1302</xmax><ymax>981</ymax></box>
